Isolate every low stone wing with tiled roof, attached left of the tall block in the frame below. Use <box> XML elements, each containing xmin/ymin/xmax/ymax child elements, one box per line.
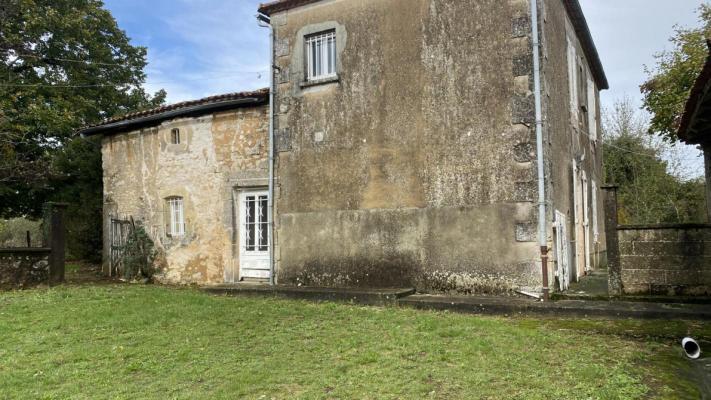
<box><xmin>83</xmin><ymin>89</ymin><xmax>269</xmax><ymax>283</ymax></box>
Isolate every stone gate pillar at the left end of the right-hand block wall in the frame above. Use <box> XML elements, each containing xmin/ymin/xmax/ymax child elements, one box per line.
<box><xmin>601</xmin><ymin>186</ymin><xmax>622</xmax><ymax>296</ymax></box>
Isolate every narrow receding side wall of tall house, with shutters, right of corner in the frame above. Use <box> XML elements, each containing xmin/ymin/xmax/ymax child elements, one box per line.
<box><xmin>539</xmin><ymin>0</ymin><xmax>606</xmax><ymax>278</ymax></box>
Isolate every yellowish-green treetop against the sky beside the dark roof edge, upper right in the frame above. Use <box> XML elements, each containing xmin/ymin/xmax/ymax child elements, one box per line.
<box><xmin>641</xmin><ymin>3</ymin><xmax>711</xmax><ymax>143</ymax></box>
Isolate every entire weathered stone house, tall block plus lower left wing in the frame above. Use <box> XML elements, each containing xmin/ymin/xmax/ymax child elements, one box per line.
<box><xmin>84</xmin><ymin>0</ymin><xmax>608</xmax><ymax>293</ymax></box>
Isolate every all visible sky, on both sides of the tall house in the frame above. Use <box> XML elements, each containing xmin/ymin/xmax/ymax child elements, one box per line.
<box><xmin>105</xmin><ymin>0</ymin><xmax>703</xmax><ymax>176</ymax></box>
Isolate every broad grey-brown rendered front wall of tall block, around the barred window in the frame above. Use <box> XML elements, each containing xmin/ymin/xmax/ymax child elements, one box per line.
<box><xmin>273</xmin><ymin>0</ymin><xmax>552</xmax><ymax>292</ymax></box>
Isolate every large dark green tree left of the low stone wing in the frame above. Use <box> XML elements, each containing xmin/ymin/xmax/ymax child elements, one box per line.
<box><xmin>0</xmin><ymin>0</ymin><xmax>165</xmax><ymax>260</ymax></box>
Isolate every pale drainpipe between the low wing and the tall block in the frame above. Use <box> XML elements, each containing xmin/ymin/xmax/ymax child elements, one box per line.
<box><xmin>257</xmin><ymin>14</ymin><xmax>276</xmax><ymax>286</ymax></box>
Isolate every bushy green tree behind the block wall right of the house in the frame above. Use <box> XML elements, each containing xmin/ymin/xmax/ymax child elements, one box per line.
<box><xmin>603</xmin><ymin>100</ymin><xmax>706</xmax><ymax>224</ymax></box>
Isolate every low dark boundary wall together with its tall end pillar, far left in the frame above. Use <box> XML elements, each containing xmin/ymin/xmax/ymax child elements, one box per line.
<box><xmin>0</xmin><ymin>203</ymin><xmax>67</xmax><ymax>290</ymax></box>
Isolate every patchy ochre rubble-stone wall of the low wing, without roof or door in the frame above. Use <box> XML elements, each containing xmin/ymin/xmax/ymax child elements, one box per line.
<box><xmin>102</xmin><ymin>105</ymin><xmax>269</xmax><ymax>283</ymax></box>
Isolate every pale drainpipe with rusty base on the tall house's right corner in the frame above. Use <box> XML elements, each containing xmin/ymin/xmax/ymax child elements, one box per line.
<box><xmin>531</xmin><ymin>0</ymin><xmax>550</xmax><ymax>300</ymax></box>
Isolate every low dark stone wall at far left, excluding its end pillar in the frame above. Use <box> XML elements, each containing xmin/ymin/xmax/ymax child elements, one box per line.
<box><xmin>0</xmin><ymin>248</ymin><xmax>51</xmax><ymax>289</ymax></box>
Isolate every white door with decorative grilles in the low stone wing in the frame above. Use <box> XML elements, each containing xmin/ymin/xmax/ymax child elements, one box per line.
<box><xmin>238</xmin><ymin>191</ymin><xmax>270</xmax><ymax>279</ymax></box>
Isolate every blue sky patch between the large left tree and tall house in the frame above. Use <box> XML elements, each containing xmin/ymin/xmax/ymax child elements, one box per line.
<box><xmin>105</xmin><ymin>0</ymin><xmax>269</xmax><ymax>103</ymax></box>
